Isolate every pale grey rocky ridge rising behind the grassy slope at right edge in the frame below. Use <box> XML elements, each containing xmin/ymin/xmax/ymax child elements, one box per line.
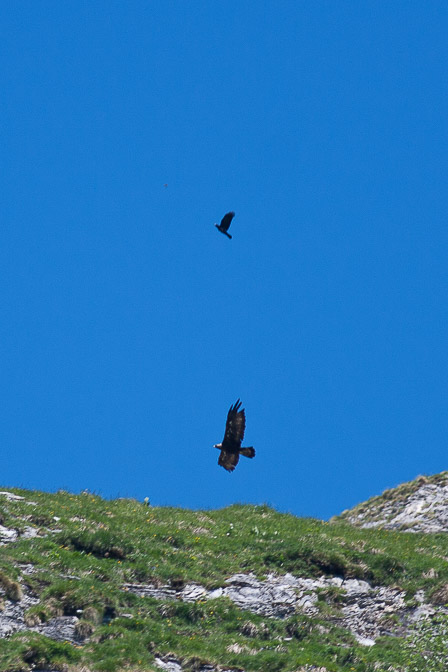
<box><xmin>341</xmin><ymin>471</ymin><xmax>448</xmax><ymax>533</ymax></box>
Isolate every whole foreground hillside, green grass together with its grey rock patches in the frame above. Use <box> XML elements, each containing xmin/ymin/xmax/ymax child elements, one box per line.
<box><xmin>0</xmin><ymin>489</ymin><xmax>448</xmax><ymax>672</ymax></box>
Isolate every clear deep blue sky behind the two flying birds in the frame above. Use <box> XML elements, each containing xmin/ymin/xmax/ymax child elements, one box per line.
<box><xmin>0</xmin><ymin>0</ymin><xmax>448</xmax><ymax>518</ymax></box>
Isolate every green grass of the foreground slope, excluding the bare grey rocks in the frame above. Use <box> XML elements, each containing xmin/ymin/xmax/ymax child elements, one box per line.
<box><xmin>0</xmin><ymin>489</ymin><xmax>448</xmax><ymax>672</ymax></box>
